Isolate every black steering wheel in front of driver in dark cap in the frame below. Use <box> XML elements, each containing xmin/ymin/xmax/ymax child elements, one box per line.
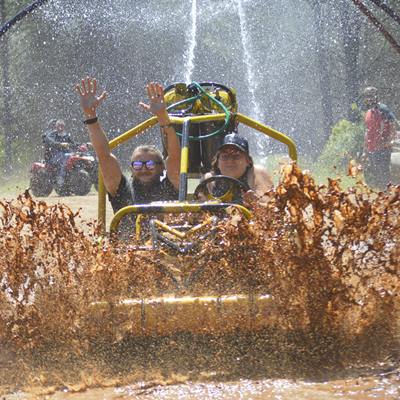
<box><xmin>193</xmin><ymin>175</ymin><xmax>250</xmax><ymax>202</ymax></box>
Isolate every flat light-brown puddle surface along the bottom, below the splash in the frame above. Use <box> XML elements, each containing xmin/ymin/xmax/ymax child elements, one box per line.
<box><xmin>6</xmin><ymin>375</ymin><xmax>400</xmax><ymax>400</ymax></box>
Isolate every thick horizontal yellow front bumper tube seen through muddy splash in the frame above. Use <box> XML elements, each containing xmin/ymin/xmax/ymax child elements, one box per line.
<box><xmin>90</xmin><ymin>294</ymin><xmax>277</xmax><ymax>336</ymax></box>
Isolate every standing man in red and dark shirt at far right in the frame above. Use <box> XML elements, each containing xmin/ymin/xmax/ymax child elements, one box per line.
<box><xmin>364</xmin><ymin>86</ymin><xmax>395</xmax><ymax>190</ymax></box>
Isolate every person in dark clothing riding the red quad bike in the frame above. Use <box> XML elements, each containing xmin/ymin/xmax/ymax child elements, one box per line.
<box><xmin>43</xmin><ymin>119</ymin><xmax>76</xmax><ymax>186</ymax></box>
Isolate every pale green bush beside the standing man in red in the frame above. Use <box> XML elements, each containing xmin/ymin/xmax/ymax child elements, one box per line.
<box><xmin>318</xmin><ymin>119</ymin><xmax>364</xmax><ymax>172</ymax></box>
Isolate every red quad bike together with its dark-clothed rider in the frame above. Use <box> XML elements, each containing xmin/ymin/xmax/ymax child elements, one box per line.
<box><xmin>30</xmin><ymin>120</ymin><xmax>97</xmax><ymax>196</ymax></box>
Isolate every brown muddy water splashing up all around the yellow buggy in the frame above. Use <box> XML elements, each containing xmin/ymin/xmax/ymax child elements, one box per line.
<box><xmin>0</xmin><ymin>166</ymin><xmax>400</xmax><ymax>399</ymax></box>
